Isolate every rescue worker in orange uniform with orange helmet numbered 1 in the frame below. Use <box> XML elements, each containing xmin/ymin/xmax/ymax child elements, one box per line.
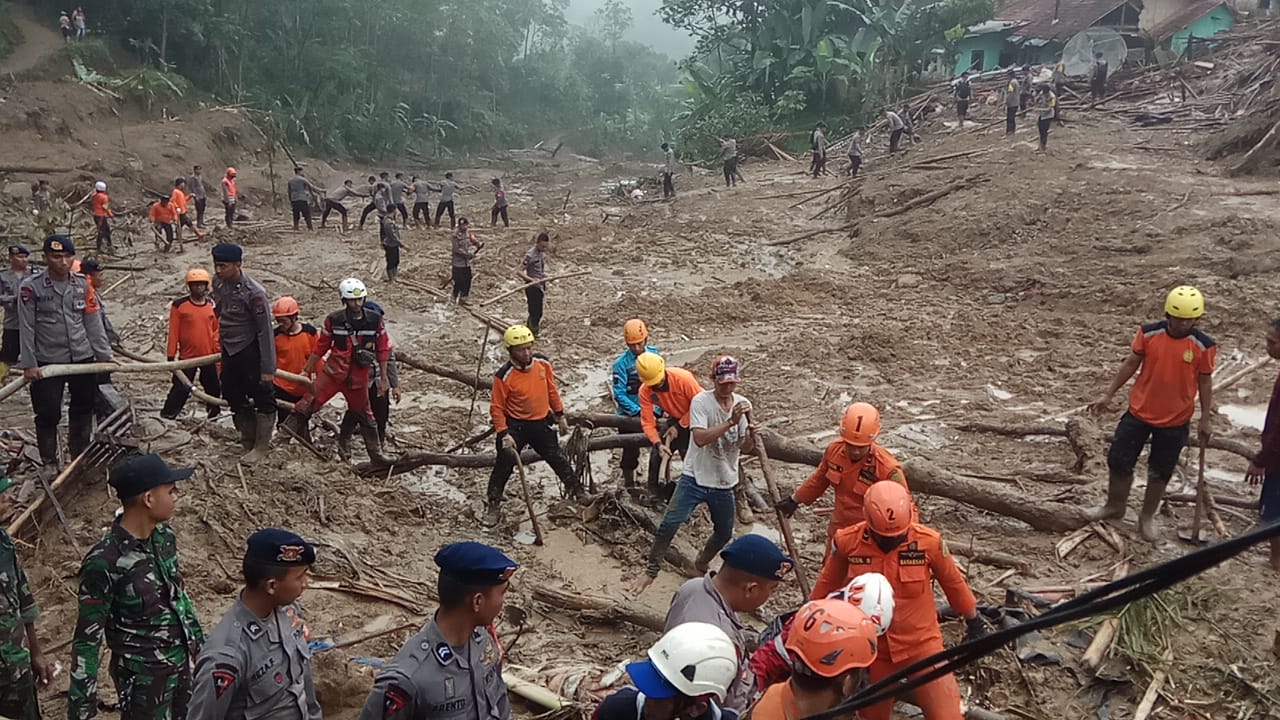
<box><xmin>778</xmin><ymin>402</ymin><xmax>908</xmax><ymax>547</ymax></box>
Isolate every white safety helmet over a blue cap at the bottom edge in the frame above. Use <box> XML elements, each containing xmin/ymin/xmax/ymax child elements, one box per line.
<box><xmin>627</xmin><ymin>623</ymin><xmax>737</xmax><ymax>702</ymax></box>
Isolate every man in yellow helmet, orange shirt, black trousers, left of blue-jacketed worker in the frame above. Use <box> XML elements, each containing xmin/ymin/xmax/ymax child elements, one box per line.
<box><xmin>484</xmin><ymin>325</ymin><xmax>582</xmax><ymax>528</ymax></box>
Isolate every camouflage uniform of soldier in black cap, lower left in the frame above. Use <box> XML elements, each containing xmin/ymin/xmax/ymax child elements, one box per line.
<box><xmin>67</xmin><ymin>521</ymin><xmax>205</xmax><ymax>720</ymax></box>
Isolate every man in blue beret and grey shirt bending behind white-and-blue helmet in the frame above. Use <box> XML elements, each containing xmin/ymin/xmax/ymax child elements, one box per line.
<box><xmin>667</xmin><ymin>532</ymin><xmax>795</xmax><ymax>714</ymax></box>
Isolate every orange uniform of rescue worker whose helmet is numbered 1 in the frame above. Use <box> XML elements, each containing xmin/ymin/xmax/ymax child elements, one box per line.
<box><xmin>795</xmin><ymin>439</ymin><xmax>910</xmax><ymax>535</ymax></box>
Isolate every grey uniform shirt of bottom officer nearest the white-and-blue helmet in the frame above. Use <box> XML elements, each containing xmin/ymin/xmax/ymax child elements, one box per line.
<box><xmin>360</xmin><ymin>620</ymin><xmax>511</xmax><ymax>720</ymax></box>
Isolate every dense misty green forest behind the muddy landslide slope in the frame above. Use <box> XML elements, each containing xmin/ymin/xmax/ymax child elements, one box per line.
<box><xmin>24</xmin><ymin>0</ymin><xmax>992</xmax><ymax>156</ymax></box>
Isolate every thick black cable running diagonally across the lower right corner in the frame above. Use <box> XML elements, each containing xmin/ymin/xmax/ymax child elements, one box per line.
<box><xmin>801</xmin><ymin>523</ymin><xmax>1280</xmax><ymax>720</ymax></box>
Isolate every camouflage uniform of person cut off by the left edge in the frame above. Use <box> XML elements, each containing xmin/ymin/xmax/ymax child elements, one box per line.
<box><xmin>0</xmin><ymin>530</ymin><xmax>40</xmax><ymax>720</ymax></box>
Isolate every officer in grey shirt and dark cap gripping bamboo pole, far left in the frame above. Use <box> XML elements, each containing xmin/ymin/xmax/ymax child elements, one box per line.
<box><xmin>18</xmin><ymin>234</ymin><xmax>111</xmax><ymax>473</ymax></box>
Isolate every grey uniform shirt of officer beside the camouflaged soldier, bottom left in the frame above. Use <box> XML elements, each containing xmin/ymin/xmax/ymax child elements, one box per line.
<box><xmin>187</xmin><ymin>600</ymin><xmax>321</xmax><ymax>720</ymax></box>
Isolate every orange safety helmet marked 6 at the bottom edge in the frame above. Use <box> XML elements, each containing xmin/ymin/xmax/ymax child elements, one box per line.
<box><xmin>786</xmin><ymin>598</ymin><xmax>877</xmax><ymax>678</ymax></box>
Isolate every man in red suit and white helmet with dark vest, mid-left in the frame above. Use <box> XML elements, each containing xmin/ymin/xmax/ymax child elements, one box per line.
<box><xmin>280</xmin><ymin>278</ymin><xmax>392</xmax><ymax>464</ymax></box>
